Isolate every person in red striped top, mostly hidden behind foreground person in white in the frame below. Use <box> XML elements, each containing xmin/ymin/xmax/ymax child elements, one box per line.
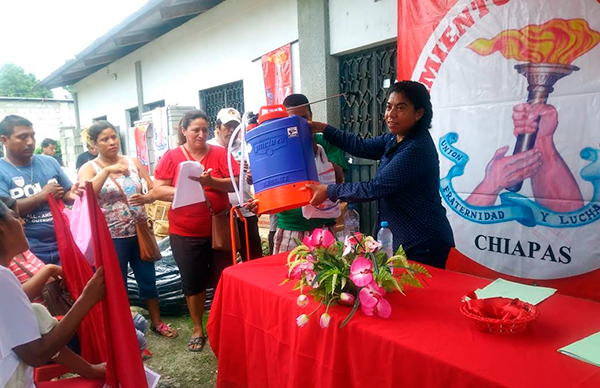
<box><xmin>0</xmin><ymin>197</ymin><xmax>62</xmax><ymax>303</ymax></box>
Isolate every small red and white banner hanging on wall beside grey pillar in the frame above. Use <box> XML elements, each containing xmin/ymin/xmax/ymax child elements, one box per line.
<box><xmin>260</xmin><ymin>43</ymin><xmax>292</xmax><ymax>105</ymax></box>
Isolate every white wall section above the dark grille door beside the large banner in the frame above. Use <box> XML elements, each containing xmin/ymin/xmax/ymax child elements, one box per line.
<box><xmin>329</xmin><ymin>0</ymin><xmax>396</xmax><ymax>55</ymax></box>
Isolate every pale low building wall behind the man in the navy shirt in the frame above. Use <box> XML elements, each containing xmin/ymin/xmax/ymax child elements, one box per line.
<box><xmin>0</xmin><ymin>99</ymin><xmax>75</xmax><ymax>141</ymax></box>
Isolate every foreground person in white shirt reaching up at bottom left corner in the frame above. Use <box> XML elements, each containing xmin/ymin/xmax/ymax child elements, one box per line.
<box><xmin>0</xmin><ymin>201</ymin><xmax>106</xmax><ymax>388</ymax></box>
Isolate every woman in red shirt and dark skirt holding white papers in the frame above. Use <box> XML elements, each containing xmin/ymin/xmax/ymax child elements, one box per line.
<box><xmin>154</xmin><ymin>110</ymin><xmax>239</xmax><ymax>352</ymax></box>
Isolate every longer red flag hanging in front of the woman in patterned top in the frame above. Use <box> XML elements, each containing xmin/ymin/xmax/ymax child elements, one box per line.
<box><xmin>85</xmin><ymin>182</ymin><xmax>148</xmax><ymax>388</ymax></box>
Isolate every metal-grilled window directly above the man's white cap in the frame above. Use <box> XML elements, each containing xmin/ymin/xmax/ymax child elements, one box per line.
<box><xmin>199</xmin><ymin>81</ymin><xmax>244</xmax><ymax>137</ymax></box>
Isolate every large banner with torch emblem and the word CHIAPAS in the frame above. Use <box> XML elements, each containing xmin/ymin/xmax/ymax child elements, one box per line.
<box><xmin>397</xmin><ymin>0</ymin><xmax>600</xmax><ymax>299</ymax></box>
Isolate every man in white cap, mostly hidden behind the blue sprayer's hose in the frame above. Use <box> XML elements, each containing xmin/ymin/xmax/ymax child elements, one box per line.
<box><xmin>207</xmin><ymin>108</ymin><xmax>262</xmax><ymax>260</ymax></box>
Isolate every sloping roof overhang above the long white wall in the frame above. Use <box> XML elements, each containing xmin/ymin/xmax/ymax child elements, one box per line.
<box><xmin>36</xmin><ymin>0</ymin><xmax>224</xmax><ymax>89</ymax></box>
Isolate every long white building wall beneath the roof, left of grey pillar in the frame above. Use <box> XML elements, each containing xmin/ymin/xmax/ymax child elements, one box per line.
<box><xmin>74</xmin><ymin>0</ymin><xmax>299</xmax><ymax>133</ymax></box>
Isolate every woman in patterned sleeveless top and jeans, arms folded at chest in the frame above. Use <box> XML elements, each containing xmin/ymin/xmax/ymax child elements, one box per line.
<box><xmin>79</xmin><ymin>120</ymin><xmax>177</xmax><ymax>338</ymax></box>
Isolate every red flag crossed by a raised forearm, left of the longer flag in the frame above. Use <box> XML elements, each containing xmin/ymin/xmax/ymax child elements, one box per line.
<box><xmin>48</xmin><ymin>195</ymin><xmax>107</xmax><ymax>364</ymax></box>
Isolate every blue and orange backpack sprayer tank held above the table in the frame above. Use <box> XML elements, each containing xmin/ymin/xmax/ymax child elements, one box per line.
<box><xmin>246</xmin><ymin>105</ymin><xmax>319</xmax><ymax>214</ymax></box>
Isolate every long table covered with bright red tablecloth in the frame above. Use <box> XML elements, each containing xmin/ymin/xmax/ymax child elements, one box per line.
<box><xmin>208</xmin><ymin>255</ymin><xmax>600</xmax><ymax>388</ymax></box>
